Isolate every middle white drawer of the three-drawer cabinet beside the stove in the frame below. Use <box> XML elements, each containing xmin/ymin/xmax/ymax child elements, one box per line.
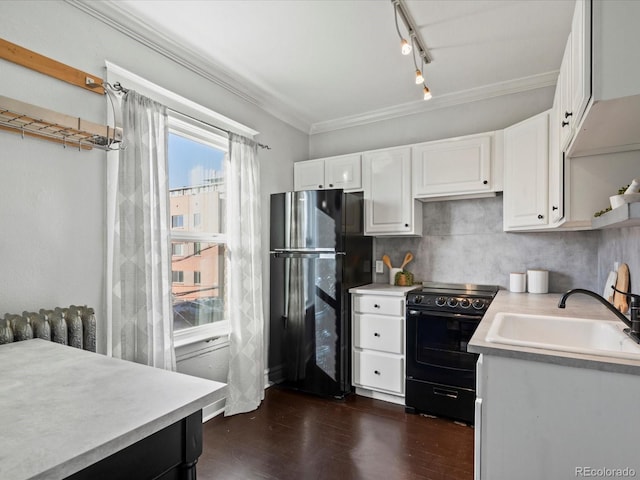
<box><xmin>353</xmin><ymin>313</ymin><xmax>404</xmax><ymax>354</ymax></box>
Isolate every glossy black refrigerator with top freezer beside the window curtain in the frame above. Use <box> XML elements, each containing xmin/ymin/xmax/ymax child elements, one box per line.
<box><xmin>269</xmin><ymin>189</ymin><xmax>373</xmax><ymax>398</ymax></box>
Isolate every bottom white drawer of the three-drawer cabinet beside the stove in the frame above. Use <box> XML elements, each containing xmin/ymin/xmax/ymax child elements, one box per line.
<box><xmin>354</xmin><ymin>352</ymin><xmax>404</xmax><ymax>394</ymax></box>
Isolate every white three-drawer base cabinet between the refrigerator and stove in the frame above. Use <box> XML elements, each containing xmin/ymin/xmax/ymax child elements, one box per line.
<box><xmin>351</xmin><ymin>285</ymin><xmax>413</xmax><ymax>405</ymax></box>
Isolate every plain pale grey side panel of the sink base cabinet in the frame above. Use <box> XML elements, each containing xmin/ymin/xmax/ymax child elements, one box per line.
<box><xmin>474</xmin><ymin>353</ymin><xmax>640</xmax><ymax>480</ymax></box>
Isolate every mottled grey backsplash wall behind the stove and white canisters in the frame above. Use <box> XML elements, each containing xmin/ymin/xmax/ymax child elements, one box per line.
<box><xmin>374</xmin><ymin>196</ymin><xmax>604</xmax><ymax>292</ymax></box>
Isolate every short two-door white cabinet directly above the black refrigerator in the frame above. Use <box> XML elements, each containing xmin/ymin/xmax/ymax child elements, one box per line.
<box><xmin>293</xmin><ymin>153</ymin><xmax>362</xmax><ymax>192</ymax></box>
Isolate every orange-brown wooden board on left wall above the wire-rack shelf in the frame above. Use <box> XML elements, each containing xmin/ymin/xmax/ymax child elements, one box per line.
<box><xmin>0</xmin><ymin>38</ymin><xmax>104</xmax><ymax>95</ymax></box>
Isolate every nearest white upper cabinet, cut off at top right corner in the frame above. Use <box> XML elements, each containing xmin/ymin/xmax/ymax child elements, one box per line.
<box><xmin>567</xmin><ymin>0</ymin><xmax>640</xmax><ymax>157</ymax></box>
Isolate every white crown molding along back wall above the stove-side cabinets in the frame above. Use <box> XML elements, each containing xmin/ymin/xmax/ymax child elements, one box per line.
<box><xmin>309</xmin><ymin>70</ymin><xmax>559</xmax><ymax>135</ymax></box>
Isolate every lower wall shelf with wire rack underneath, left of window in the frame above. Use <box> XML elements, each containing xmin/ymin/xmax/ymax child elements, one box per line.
<box><xmin>0</xmin><ymin>95</ymin><xmax>122</xmax><ymax>150</ymax></box>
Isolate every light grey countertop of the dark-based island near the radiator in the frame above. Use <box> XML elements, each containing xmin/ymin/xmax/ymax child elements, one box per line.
<box><xmin>0</xmin><ymin>340</ymin><xmax>226</xmax><ymax>480</ymax></box>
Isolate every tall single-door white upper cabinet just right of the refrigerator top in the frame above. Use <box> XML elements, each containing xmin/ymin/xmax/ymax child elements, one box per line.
<box><xmin>362</xmin><ymin>147</ymin><xmax>422</xmax><ymax>235</ymax></box>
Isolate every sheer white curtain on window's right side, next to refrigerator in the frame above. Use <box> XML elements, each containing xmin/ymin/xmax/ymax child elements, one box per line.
<box><xmin>224</xmin><ymin>133</ymin><xmax>264</xmax><ymax>416</ymax></box>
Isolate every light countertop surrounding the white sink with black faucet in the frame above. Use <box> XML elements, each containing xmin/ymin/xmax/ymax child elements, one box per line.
<box><xmin>467</xmin><ymin>290</ymin><xmax>640</xmax><ymax>375</ymax></box>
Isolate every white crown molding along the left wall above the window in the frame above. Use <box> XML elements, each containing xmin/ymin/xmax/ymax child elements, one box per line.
<box><xmin>64</xmin><ymin>0</ymin><xmax>311</xmax><ymax>134</ymax></box>
